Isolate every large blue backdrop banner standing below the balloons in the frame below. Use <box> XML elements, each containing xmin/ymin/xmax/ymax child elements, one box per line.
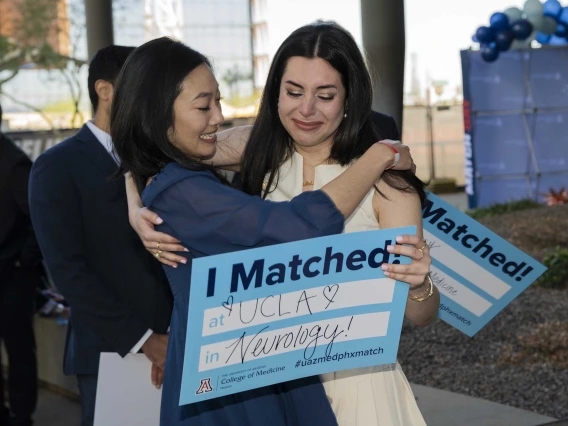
<box><xmin>461</xmin><ymin>46</ymin><xmax>568</xmax><ymax>208</ymax></box>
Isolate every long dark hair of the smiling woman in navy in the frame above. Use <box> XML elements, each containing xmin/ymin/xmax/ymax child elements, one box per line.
<box><xmin>110</xmin><ymin>37</ymin><xmax>223</xmax><ymax>191</ymax></box>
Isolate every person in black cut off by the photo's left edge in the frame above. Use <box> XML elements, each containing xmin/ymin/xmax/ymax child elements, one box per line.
<box><xmin>0</xmin><ymin>106</ymin><xmax>41</xmax><ymax>426</ymax></box>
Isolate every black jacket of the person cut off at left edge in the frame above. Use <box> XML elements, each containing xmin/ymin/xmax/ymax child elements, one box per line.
<box><xmin>0</xmin><ymin>133</ymin><xmax>41</xmax><ymax>282</ymax></box>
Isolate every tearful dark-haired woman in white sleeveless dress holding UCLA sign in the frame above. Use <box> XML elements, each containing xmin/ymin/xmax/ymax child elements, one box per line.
<box><xmin>131</xmin><ymin>22</ymin><xmax>439</xmax><ymax>426</ymax></box>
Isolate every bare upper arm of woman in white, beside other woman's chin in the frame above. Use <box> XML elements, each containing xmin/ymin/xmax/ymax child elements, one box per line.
<box><xmin>204</xmin><ymin>126</ymin><xmax>252</xmax><ymax>172</ymax></box>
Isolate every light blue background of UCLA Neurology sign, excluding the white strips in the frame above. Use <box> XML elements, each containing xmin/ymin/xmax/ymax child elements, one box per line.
<box><xmin>179</xmin><ymin>227</ymin><xmax>416</xmax><ymax>405</ymax></box>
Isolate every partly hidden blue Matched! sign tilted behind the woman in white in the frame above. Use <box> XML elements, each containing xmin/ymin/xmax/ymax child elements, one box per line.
<box><xmin>422</xmin><ymin>194</ymin><xmax>546</xmax><ymax>336</ymax></box>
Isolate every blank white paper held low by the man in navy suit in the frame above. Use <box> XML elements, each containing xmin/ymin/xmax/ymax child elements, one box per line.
<box><xmin>95</xmin><ymin>353</ymin><xmax>162</xmax><ymax>426</ymax></box>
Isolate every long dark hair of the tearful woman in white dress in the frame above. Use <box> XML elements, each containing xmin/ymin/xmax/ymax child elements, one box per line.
<box><xmin>242</xmin><ymin>21</ymin><xmax>426</xmax><ymax>203</ymax></box>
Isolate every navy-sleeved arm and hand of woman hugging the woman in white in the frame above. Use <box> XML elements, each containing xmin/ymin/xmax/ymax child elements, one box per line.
<box><xmin>149</xmin><ymin>144</ymin><xmax>410</xmax><ymax>257</ymax></box>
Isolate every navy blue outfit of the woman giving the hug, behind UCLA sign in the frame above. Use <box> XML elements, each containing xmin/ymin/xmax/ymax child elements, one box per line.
<box><xmin>142</xmin><ymin>163</ymin><xmax>344</xmax><ymax>426</ymax></box>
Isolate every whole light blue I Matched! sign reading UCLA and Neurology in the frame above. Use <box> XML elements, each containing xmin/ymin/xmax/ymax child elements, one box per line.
<box><xmin>180</xmin><ymin>227</ymin><xmax>416</xmax><ymax>405</ymax></box>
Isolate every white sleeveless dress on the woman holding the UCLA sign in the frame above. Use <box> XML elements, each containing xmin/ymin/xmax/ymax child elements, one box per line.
<box><xmin>266</xmin><ymin>152</ymin><xmax>426</xmax><ymax>426</ymax></box>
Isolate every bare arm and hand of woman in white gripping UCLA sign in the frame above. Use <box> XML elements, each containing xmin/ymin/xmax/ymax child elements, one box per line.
<box><xmin>373</xmin><ymin>182</ymin><xmax>440</xmax><ymax>326</ymax></box>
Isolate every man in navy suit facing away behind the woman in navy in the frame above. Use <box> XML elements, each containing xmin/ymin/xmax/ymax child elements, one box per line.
<box><xmin>30</xmin><ymin>46</ymin><xmax>172</xmax><ymax>426</ymax></box>
